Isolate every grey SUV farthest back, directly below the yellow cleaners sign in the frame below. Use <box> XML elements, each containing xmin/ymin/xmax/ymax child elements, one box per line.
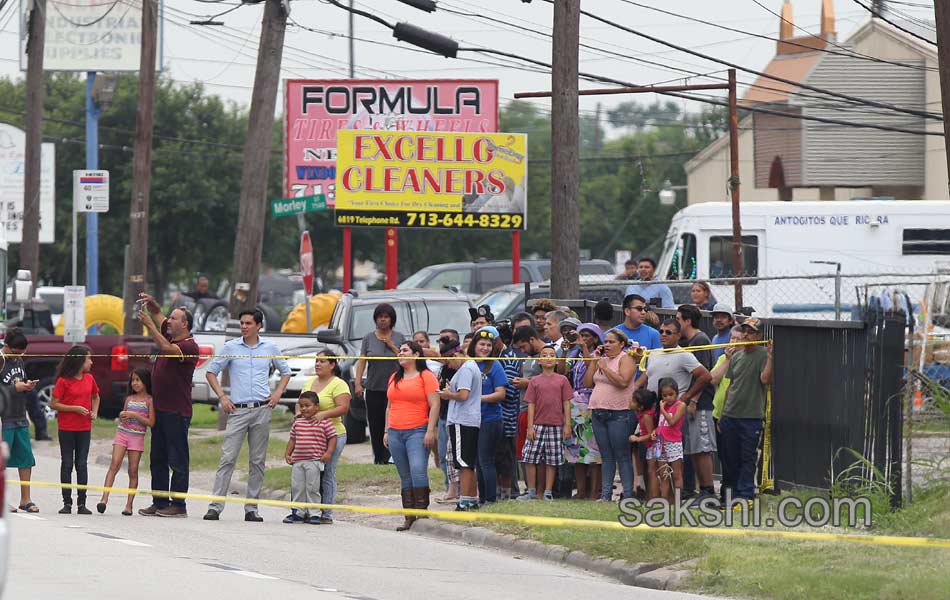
<box><xmin>397</xmin><ymin>259</ymin><xmax>614</xmax><ymax>295</ymax></box>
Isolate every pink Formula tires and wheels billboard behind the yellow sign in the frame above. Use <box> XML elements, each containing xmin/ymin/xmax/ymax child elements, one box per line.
<box><xmin>284</xmin><ymin>79</ymin><xmax>498</xmax><ymax>208</ymax></box>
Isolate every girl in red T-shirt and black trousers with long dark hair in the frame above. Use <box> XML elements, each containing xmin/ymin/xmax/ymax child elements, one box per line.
<box><xmin>50</xmin><ymin>346</ymin><xmax>99</xmax><ymax>515</ymax></box>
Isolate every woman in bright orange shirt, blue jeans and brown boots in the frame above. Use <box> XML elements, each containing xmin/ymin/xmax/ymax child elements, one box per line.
<box><xmin>383</xmin><ymin>341</ymin><xmax>439</xmax><ymax>531</ymax></box>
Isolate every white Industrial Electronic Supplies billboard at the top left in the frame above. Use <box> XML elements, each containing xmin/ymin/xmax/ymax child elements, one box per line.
<box><xmin>20</xmin><ymin>0</ymin><xmax>163</xmax><ymax>71</ymax></box>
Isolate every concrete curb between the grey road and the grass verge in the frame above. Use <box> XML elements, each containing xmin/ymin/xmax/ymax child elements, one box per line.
<box><xmin>411</xmin><ymin>519</ymin><xmax>697</xmax><ymax>590</ymax></box>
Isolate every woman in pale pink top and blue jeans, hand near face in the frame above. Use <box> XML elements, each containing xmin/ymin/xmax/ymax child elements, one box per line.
<box><xmin>584</xmin><ymin>329</ymin><xmax>637</xmax><ymax>500</ymax></box>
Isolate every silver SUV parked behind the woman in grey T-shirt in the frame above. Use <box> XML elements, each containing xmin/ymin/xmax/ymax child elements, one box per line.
<box><xmin>308</xmin><ymin>290</ymin><xmax>472</xmax><ymax>444</ymax></box>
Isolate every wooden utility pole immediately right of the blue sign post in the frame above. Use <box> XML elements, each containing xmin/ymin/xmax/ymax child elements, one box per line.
<box><xmin>123</xmin><ymin>0</ymin><xmax>158</xmax><ymax>334</ymax></box>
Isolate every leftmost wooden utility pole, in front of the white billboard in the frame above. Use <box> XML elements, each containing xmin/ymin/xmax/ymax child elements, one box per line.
<box><xmin>20</xmin><ymin>0</ymin><xmax>46</xmax><ymax>281</ymax></box>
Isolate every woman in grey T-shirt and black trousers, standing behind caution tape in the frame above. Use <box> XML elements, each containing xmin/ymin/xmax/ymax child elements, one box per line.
<box><xmin>353</xmin><ymin>303</ymin><xmax>405</xmax><ymax>465</ymax></box>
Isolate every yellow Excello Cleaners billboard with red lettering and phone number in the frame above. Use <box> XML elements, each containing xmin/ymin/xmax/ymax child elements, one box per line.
<box><xmin>336</xmin><ymin>131</ymin><xmax>528</xmax><ymax>229</ymax></box>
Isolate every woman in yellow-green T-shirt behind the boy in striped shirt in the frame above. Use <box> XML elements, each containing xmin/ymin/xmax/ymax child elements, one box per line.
<box><xmin>301</xmin><ymin>350</ymin><xmax>352</xmax><ymax>525</ymax></box>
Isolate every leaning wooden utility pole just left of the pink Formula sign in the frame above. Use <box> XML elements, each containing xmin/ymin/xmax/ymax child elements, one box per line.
<box><xmin>229</xmin><ymin>0</ymin><xmax>287</xmax><ymax>316</ymax></box>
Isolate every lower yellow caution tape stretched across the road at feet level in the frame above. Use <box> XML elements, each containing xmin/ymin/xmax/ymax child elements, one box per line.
<box><xmin>6</xmin><ymin>479</ymin><xmax>950</xmax><ymax>549</ymax></box>
